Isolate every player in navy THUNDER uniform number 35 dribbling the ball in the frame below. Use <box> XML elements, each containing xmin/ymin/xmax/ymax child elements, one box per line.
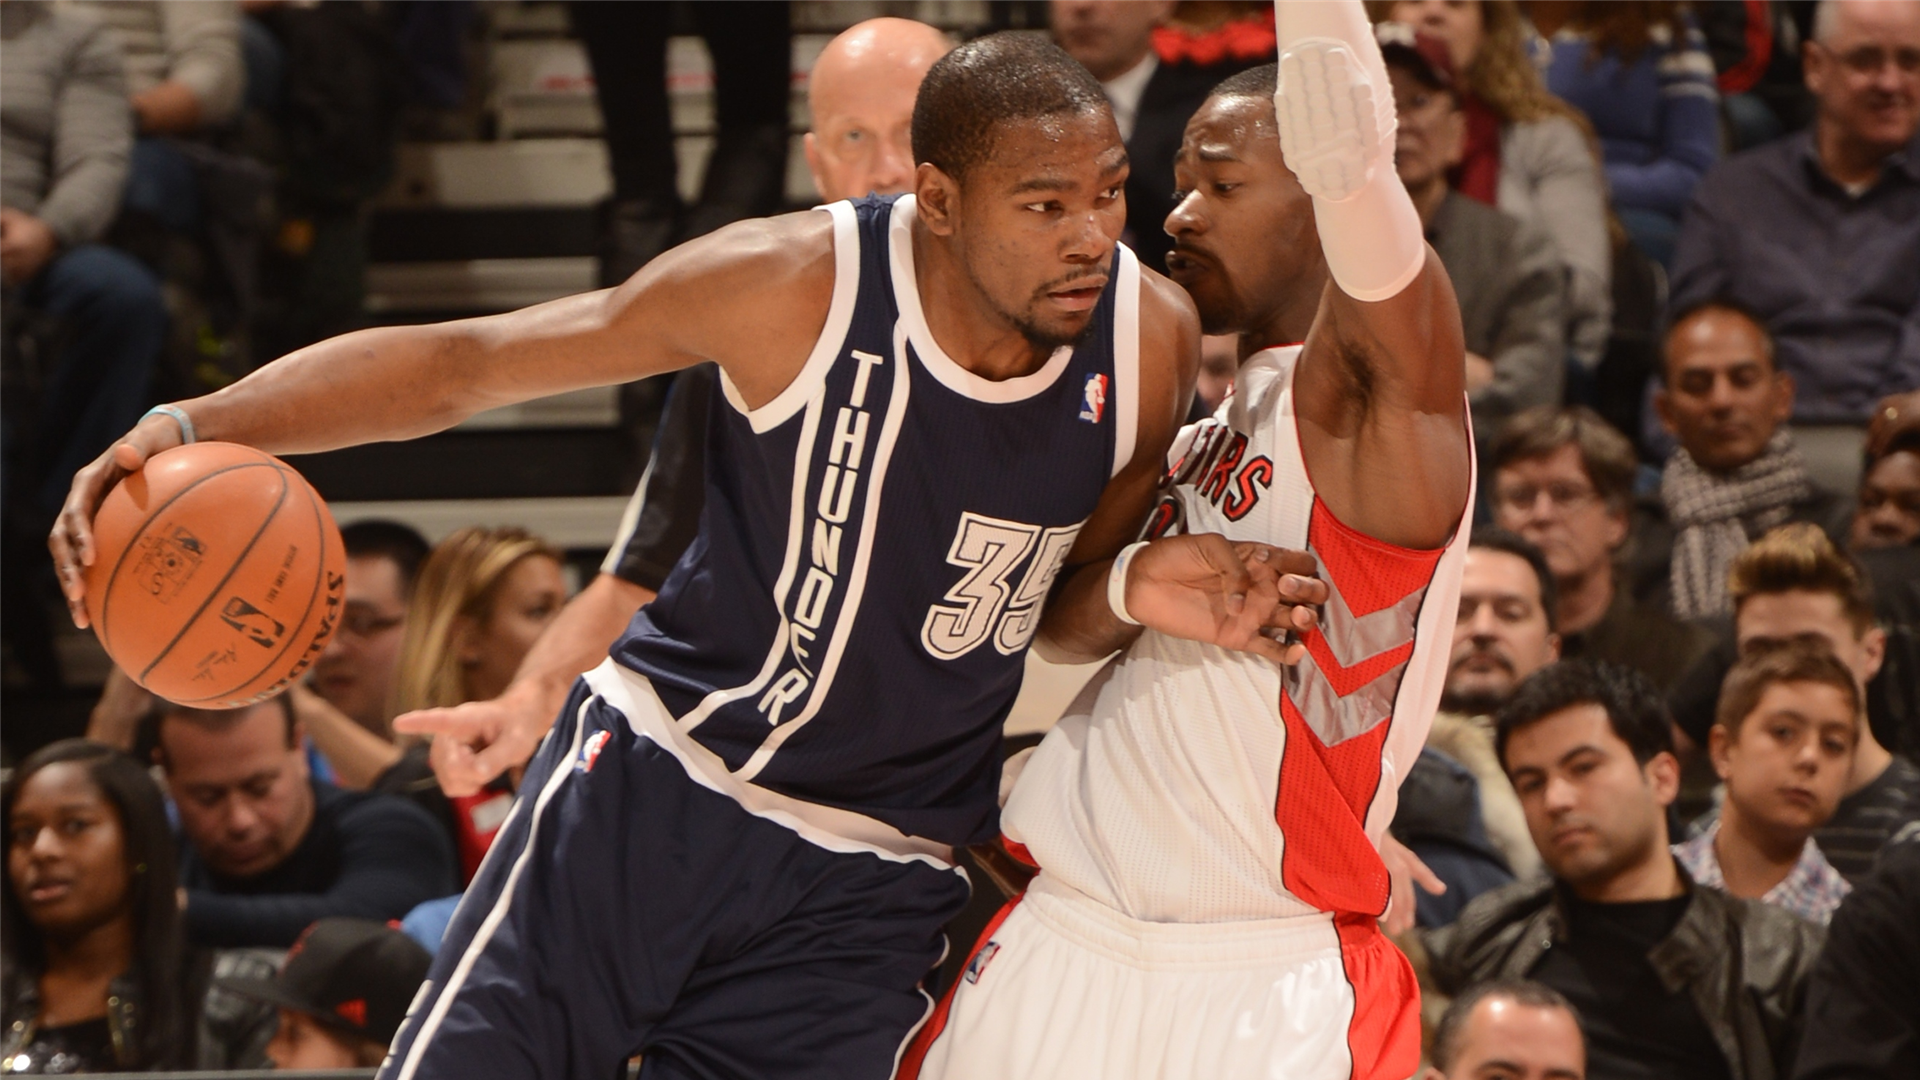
<box><xmin>50</xmin><ymin>35</ymin><xmax>1325</xmax><ymax>1080</ymax></box>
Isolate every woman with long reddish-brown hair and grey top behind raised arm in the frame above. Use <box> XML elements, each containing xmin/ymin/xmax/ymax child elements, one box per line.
<box><xmin>1367</xmin><ymin>0</ymin><xmax>1613</xmax><ymax>368</ymax></box>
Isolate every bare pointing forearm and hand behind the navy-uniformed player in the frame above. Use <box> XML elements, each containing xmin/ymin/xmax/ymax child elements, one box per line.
<box><xmin>394</xmin><ymin>575</ymin><xmax>653</xmax><ymax>798</ymax></box>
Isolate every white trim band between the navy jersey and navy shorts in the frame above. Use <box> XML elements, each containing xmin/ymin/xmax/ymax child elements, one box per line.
<box><xmin>582</xmin><ymin>657</ymin><xmax>958</xmax><ymax>872</ymax></box>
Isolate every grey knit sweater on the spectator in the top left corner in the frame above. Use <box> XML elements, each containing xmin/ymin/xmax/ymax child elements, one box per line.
<box><xmin>0</xmin><ymin>0</ymin><xmax>132</xmax><ymax>244</ymax></box>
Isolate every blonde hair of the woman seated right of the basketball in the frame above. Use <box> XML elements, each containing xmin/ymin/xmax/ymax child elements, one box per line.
<box><xmin>396</xmin><ymin>527</ymin><xmax>561</xmax><ymax>713</ymax></box>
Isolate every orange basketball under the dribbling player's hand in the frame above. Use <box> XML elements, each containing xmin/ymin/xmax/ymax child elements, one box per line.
<box><xmin>86</xmin><ymin>442</ymin><xmax>346</xmax><ymax>709</ymax></box>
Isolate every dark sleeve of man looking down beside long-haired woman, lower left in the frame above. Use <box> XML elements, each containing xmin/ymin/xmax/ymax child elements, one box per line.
<box><xmin>186</xmin><ymin>796</ymin><xmax>459</xmax><ymax>949</ymax></box>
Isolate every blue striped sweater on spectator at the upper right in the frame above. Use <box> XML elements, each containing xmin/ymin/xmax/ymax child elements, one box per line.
<box><xmin>1534</xmin><ymin>19</ymin><xmax>1720</xmax><ymax>217</ymax></box>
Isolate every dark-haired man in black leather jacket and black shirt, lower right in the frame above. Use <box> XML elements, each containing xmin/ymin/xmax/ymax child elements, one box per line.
<box><xmin>1423</xmin><ymin>661</ymin><xmax>1820</xmax><ymax>1080</ymax></box>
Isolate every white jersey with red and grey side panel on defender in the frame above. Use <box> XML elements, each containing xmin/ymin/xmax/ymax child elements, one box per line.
<box><xmin>1002</xmin><ymin>346</ymin><xmax>1473</xmax><ymax>922</ymax></box>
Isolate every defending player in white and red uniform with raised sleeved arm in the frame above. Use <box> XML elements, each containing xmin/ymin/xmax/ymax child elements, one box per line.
<box><xmin>900</xmin><ymin>0</ymin><xmax>1473</xmax><ymax>1080</ymax></box>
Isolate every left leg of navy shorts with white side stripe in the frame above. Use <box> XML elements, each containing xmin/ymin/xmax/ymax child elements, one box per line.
<box><xmin>384</xmin><ymin>684</ymin><xmax>714</xmax><ymax>1080</ymax></box>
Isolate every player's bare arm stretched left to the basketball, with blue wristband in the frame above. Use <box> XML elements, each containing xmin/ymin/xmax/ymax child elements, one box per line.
<box><xmin>48</xmin><ymin>213</ymin><xmax>833</xmax><ymax>626</ymax></box>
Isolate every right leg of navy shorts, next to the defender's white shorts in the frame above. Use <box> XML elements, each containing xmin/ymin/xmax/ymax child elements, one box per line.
<box><xmin>641</xmin><ymin>851</ymin><xmax>968</xmax><ymax>1080</ymax></box>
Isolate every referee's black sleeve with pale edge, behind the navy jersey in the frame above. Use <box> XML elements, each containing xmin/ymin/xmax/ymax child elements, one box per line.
<box><xmin>601</xmin><ymin>363</ymin><xmax>720</xmax><ymax>592</ymax></box>
